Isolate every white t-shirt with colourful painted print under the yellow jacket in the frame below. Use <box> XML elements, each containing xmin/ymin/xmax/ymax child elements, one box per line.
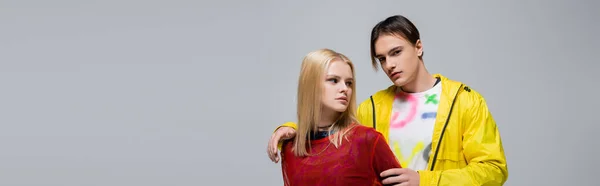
<box><xmin>389</xmin><ymin>83</ymin><xmax>442</xmax><ymax>170</ymax></box>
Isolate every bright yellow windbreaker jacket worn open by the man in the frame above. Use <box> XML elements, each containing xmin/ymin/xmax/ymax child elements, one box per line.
<box><xmin>278</xmin><ymin>74</ymin><xmax>508</xmax><ymax>186</ymax></box>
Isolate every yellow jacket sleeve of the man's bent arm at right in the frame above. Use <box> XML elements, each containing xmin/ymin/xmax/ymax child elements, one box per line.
<box><xmin>419</xmin><ymin>97</ymin><xmax>508</xmax><ymax>186</ymax></box>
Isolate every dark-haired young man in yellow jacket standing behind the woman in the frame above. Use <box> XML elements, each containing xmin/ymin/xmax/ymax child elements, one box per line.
<box><xmin>267</xmin><ymin>15</ymin><xmax>508</xmax><ymax>185</ymax></box>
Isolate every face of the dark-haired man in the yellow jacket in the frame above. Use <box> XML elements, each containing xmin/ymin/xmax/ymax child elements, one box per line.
<box><xmin>375</xmin><ymin>35</ymin><xmax>423</xmax><ymax>87</ymax></box>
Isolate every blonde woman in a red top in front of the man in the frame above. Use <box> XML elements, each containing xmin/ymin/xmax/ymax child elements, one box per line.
<box><xmin>281</xmin><ymin>49</ymin><xmax>400</xmax><ymax>186</ymax></box>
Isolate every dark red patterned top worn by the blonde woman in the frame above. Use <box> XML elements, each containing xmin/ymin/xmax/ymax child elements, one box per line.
<box><xmin>281</xmin><ymin>125</ymin><xmax>400</xmax><ymax>186</ymax></box>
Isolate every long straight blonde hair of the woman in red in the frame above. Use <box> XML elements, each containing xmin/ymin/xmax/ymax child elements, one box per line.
<box><xmin>293</xmin><ymin>49</ymin><xmax>357</xmax><ymax>156</ymax></box>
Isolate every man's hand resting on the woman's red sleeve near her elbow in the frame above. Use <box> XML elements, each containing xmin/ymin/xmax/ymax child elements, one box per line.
<box><xmin>380</xmin><ymin>168</ymin><xmax>420</xmax><ymax>186</ymax></box>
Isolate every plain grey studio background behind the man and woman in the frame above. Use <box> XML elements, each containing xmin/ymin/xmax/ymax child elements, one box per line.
<box><xmin>0</xmin><ymin>0</ymin><xmax>600</xmax><ymax>186</ymax></box>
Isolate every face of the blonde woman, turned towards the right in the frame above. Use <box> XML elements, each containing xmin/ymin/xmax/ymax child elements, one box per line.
<box><xmin>321</xmin><ymin>59</ymin><xmax>354</xmax><ymax>112</ymax></box>
